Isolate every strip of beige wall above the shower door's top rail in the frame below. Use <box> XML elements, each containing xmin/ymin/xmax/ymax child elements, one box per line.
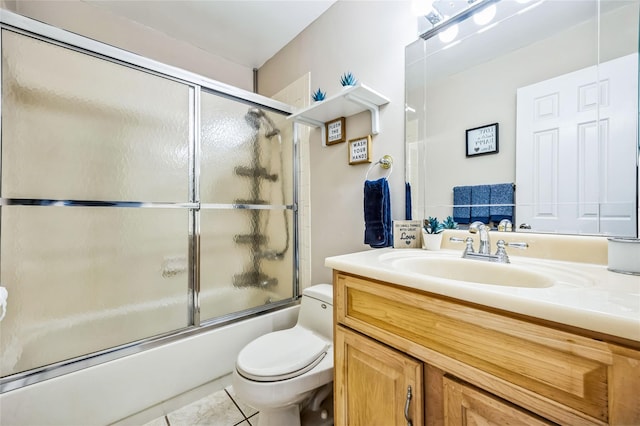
<box><xmin>6</xmin><ymin>0</ymin><xmax>253</xmax><ymax>91</ymax></box>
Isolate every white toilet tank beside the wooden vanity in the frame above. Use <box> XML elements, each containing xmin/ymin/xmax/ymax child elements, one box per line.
<box><xmin>298</xmin><ymin>284</ymin><xmax>333</xmax><ymax>340</ymax></box>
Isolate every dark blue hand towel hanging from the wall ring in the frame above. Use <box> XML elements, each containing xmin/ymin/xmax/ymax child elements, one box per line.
<box><xmin>364</xmin><ymin>178</ymin><xmax>393</xmax><ymax>248</ymax></box>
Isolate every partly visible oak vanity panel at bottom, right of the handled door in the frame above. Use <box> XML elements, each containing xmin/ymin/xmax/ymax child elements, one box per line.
<box><xmin>443</xmin><ymin>377</ymin><xmax>555</xmax><ymax>426</ymax></box>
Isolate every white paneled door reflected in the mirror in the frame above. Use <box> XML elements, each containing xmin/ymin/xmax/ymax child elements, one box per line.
<box><xmin>516</xmin><ymin>54</ymin><xmax>638</xmax><ymax>236</ymax></box>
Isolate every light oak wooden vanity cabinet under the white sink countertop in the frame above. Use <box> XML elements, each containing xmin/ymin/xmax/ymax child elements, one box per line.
<box><xmin>334</xmin><ymin>271</ymin><xmax>640</xmax><ymax>426</ymax></box>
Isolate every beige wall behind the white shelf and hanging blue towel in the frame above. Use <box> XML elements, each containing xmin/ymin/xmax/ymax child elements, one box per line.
<box><xmin>258</xmin><ymin>1</ymin><xmax>417</xmax><ymax>283</ymax></box>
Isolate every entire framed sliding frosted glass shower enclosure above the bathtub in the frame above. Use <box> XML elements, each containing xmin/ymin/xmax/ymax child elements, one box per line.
<box><xmin>0</xmin><ymin>11</ymin><xmax>298</xmax><ymax>392</ymax></box>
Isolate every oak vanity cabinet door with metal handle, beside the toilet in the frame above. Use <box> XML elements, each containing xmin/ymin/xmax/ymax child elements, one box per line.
<box><xmin>335</xmin><ymin>326</ymin><xmax>424</xmax><ymax>426</ymax></box>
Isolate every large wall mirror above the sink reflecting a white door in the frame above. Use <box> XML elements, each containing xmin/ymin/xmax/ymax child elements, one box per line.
<box><xmin>405</xmin><ymin>0</ymin><xmax>640</xmax><ymax>237</ymax></box>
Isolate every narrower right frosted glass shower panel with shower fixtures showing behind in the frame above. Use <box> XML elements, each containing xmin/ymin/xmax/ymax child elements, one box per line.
<box><xmin>199</xmin><ymin>91</ymin><xmax>295</xmax><ymax>321</ymax></box>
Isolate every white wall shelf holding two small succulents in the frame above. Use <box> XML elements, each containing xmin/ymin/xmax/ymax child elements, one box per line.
<box><xmin>287</xmin><ymin>83</ymin><xmax>389</xmax><ymax>146</ymax></box>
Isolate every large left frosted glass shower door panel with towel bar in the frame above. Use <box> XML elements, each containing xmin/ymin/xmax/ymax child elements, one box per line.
<box><xmin>0</xmin><ymin>30</ymin><xmax>194</xmax><ymax>377</ymax></box>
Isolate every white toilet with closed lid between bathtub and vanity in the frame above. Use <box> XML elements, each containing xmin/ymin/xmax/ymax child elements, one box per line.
<box><xmin>233</xmin><ymin>284</ymin><xmax>333</xmax><ymax>426</ymax></box>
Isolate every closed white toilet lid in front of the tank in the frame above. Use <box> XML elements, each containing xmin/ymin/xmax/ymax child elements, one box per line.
<box><xmin>236</xmin><ymin>327</ymin><xmax>330</xmax><ymax>382</ymax></box>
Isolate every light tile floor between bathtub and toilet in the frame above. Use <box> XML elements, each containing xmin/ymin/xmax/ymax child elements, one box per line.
<box><xmin>144</xmin><ymin>386</ymin><xmax>259</xmax><ymax>426</ymax></box>
